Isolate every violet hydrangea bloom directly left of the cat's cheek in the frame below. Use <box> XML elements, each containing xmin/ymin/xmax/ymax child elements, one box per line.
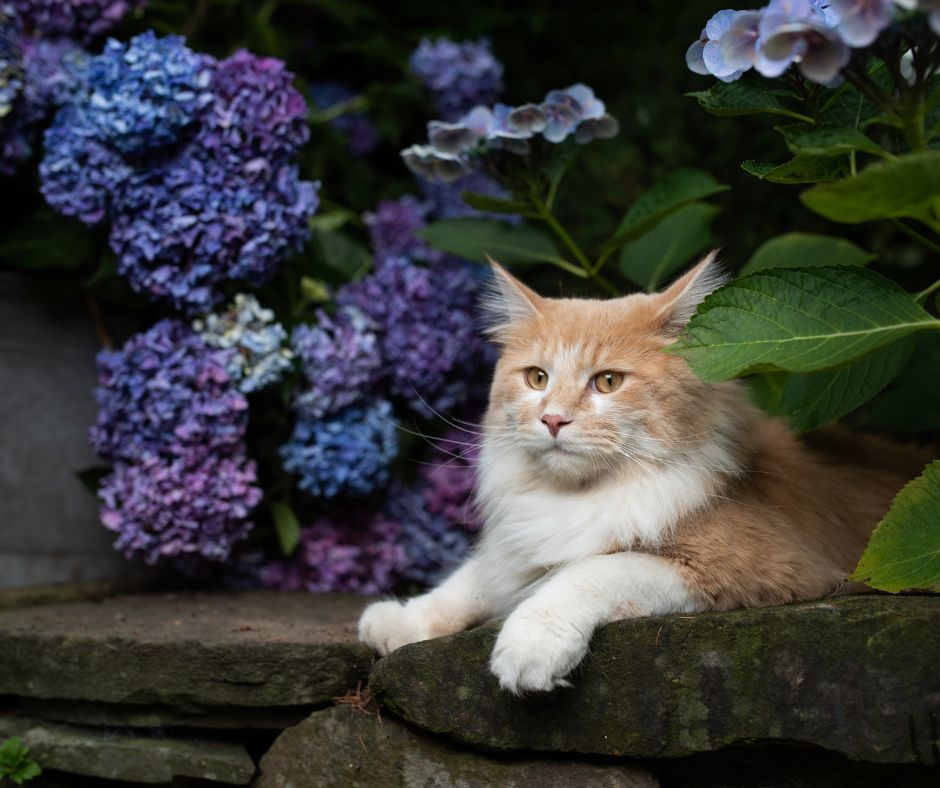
<box><xmin>336</xmin><ymin>258</ymin><xmax>482</xmax><ymax>415</ymax></box>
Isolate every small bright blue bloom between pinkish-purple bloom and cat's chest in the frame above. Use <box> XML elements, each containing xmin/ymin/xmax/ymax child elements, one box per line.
<box><xmin>281</xmin><ymin>400</ymin><xmax>398</xmax><ymax>498</ymax></box>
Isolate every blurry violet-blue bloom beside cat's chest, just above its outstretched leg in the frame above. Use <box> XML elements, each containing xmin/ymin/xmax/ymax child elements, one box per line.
<box><xmin>385</xmin><ymin>485</ymin><xmax>471</xmax><ymax>586</ymax></box>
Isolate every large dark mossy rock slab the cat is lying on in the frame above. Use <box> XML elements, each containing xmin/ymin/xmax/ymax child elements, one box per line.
<box><xmin>369</xmin><ymin>596</ymin><xmax>940</xmax><ymax>765</ymax></box>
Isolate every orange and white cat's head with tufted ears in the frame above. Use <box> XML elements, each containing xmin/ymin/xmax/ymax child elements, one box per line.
<box><xmin>485</xmin><ymin>253</ymin><xmax>723</xmax><ymax>485</ymax></box>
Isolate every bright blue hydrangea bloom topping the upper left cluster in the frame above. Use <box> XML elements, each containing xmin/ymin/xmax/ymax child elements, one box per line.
<box><xmin>82</xmin><ymin>30</ymin><xmax>214</xmax><ymax>154</ymax></box>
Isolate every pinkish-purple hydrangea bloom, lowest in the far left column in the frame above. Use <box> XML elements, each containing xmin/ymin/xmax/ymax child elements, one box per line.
<box><xmin>98</xmin><ymin>450</ymin><xmax>261</xmax><ymax>564</ymax></box>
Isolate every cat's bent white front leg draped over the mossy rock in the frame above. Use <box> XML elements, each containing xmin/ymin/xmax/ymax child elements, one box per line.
<box><xmin>490</xmin><ymin>552</ymin><xmax>698</xmax><ymax>695</ymax></box>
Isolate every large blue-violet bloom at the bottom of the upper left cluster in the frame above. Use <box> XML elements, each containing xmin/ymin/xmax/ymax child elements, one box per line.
<box><xmin>110</xmin><ymin>149</ymin><xmax>319</xmax><ymax>314</ymax></box>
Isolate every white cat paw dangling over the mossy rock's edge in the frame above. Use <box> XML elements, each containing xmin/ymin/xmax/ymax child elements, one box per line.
<box><xmin>490</xmin><ymin>611</ymin><xmax>588</xmax><ymax>695</ymax></box>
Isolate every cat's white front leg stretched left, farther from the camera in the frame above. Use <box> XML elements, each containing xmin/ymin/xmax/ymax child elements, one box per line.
<box><xmin>359</xmin><ymin>558</ymin><xmax>489</xmax><ymax>656</ymax></box>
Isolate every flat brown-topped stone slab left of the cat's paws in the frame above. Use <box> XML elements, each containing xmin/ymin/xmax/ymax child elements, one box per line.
<box><xmin>0</xmin><ymin>592</ymin><xmax>372</xmax><ymax>709</ymax></box>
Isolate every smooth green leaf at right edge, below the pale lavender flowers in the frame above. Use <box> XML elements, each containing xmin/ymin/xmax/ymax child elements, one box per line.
<box><xmin>800</xmin><ymin>151</ymin><xmax>940</xmax><ymax>224</ymax></box>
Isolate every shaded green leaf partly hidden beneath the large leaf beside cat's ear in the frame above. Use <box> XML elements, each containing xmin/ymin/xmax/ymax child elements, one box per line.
<box><xmin>776</xmin><ymin>336</ymin><xmax>915</xmax><ymax>432</ymax></box>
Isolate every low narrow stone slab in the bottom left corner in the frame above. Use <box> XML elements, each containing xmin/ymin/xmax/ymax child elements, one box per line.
<box><xmin>0</xmin><ymin>717</ymin><xmax>255</xmax><ymax>785</ymax></box>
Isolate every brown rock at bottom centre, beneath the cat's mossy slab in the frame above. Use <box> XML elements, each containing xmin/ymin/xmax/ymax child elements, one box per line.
<box><xmin>253</xmin><ymin>708</ymin><xmax>659</xmax><ymax>788</ymax></box>
